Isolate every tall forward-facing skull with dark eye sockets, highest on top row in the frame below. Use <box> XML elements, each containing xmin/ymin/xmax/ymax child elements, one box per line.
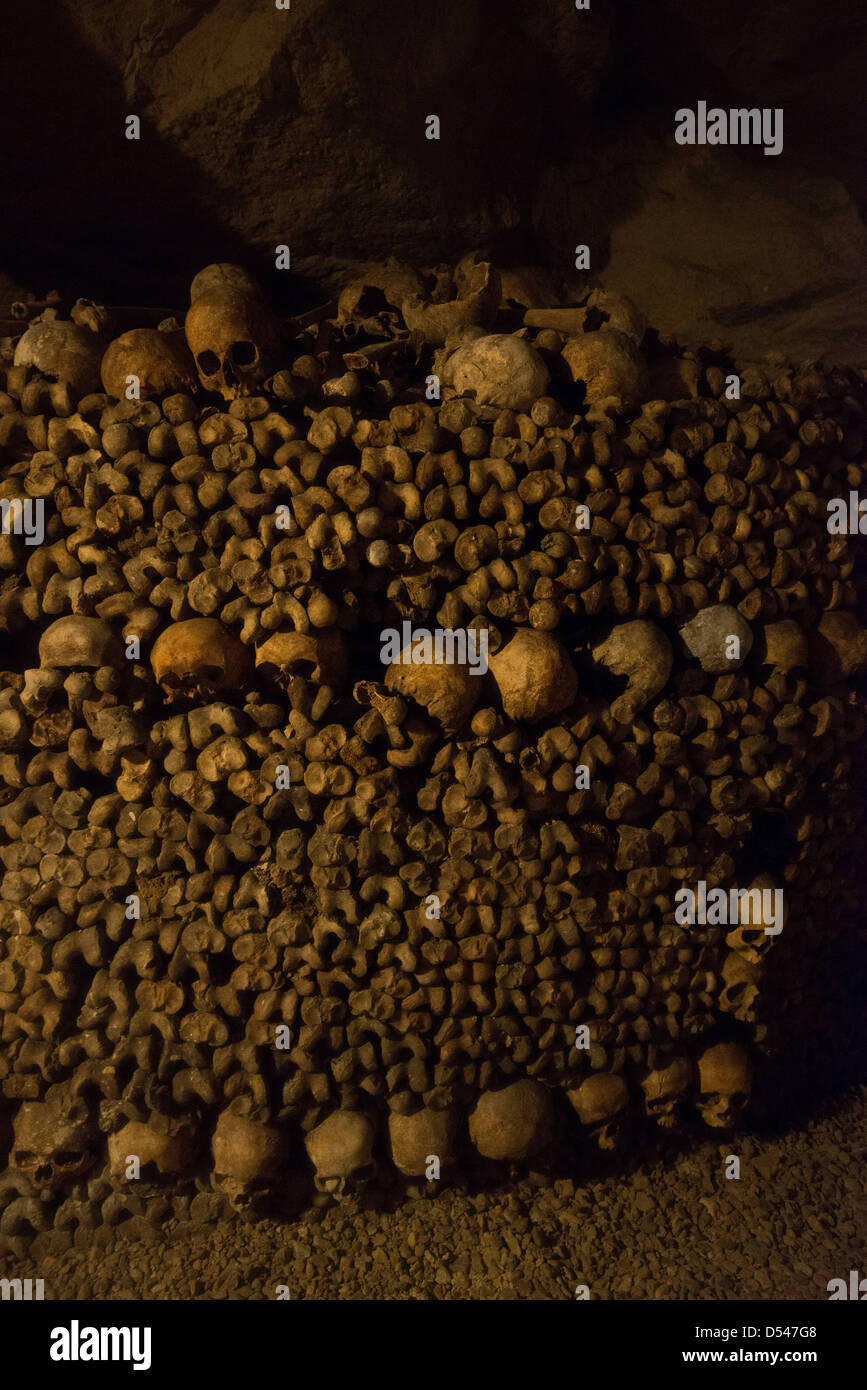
<box><xmin>183</xmin><ymin>264</ymin><xmax>279</xmax><ymax>400</ymax></box>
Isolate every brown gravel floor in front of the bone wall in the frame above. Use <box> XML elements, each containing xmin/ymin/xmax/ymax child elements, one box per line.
<box><xmin>0</xmin><ymin>1087</ymin><xmax>867</xmax><ymax>1300</ymax></box>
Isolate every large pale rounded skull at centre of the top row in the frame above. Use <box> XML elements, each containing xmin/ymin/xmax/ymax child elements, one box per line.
<box><xmin>443</xmin><ymin>334</ymin><xmax>550</xmax><ymax>410</ymax></box>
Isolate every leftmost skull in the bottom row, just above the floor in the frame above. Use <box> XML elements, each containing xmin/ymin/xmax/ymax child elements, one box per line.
<box><xmin>13</xmin><ymin>1084</ymin><xmax>100</xmax><ymax>1193</ymax></box>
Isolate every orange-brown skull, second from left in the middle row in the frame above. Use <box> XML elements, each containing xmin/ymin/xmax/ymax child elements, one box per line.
<box><xmin>150</xmin><ymin>617</ymin><xmax>250</xmax><ymax>701</ymax></box>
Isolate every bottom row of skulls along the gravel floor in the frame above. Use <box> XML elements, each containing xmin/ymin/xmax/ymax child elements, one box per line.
<box><xmin>5</xmin><ymin>1043</ymin><xmax>752</xmax><ymax>1209</ymax></box>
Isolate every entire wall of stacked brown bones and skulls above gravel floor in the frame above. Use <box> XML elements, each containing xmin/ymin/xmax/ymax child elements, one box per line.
<box><xmin>0</xmin><ymin>257</ymin><xmax>867</xmax><ymax>1237</ymax></box>
